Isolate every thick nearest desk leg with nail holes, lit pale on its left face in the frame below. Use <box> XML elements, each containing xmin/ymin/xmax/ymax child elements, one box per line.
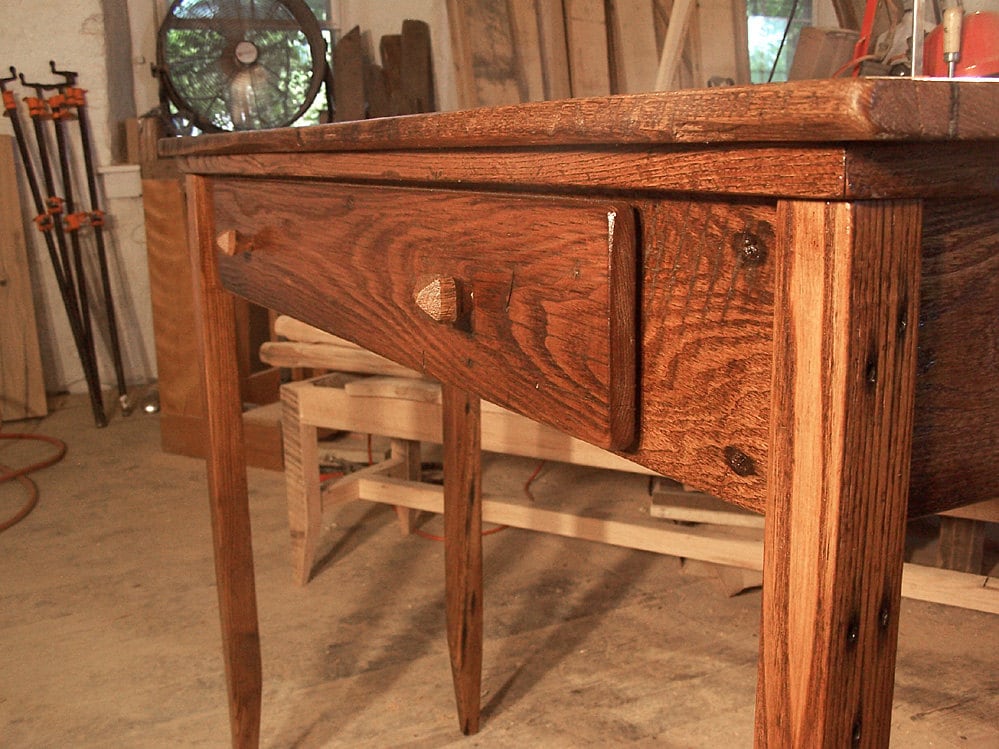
<box><xmin>756</xmin><ymin>202</ymin><xmax>922</xmax><ymax>749</ymax></box>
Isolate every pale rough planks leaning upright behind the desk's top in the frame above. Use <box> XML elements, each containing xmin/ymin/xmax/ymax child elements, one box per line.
<box><xmin>448</xmin><ymin>0</ymin><xmax>749</xmax><ymax>108</ymax></box>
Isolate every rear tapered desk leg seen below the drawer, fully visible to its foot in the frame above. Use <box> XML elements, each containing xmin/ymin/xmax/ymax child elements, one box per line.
<box><xmin>442</xmin><ymin>385</ymin><xmax>482</xmax><ymax>734</ymax></box>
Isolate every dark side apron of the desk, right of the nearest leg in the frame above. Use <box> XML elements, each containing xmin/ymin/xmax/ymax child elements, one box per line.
<box><xmin>909</xmin><ymin>198</ymin><xmax>999</xmax><ymax>516</ymax></box>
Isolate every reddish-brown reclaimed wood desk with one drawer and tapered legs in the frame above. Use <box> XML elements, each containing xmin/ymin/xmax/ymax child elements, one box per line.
<box><xmin>161</xmin><ymin>79</ymin><xmax>999</xmax><ymax>747</ymax></box>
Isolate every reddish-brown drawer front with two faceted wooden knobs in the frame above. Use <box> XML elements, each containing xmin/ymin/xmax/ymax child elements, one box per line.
<box><xmin>212</xmin><ymin>178</ymin><xmax>637</xmax><ymax>449</ymax></box>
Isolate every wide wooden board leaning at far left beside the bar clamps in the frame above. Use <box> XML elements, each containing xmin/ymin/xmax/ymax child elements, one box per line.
<box><xmin>0</xmin><ymin>135</ymin><xmax>48</xmax><ymax>422</ymax></box>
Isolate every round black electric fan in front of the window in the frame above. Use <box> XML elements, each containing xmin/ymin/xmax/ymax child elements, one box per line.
<box><xmin>156</xmin><ymin>0</ymin><xmax>331</xmax><ymax>132</ymax></box>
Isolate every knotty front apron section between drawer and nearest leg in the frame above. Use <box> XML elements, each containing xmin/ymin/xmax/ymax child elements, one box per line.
<box><xmin>632</xmin><ymin>200</ymin><xmax>776</xmax><ymax>511</ymax></box>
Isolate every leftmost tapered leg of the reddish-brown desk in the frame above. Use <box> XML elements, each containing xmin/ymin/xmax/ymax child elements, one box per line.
<box><xmin>186</xmin><ymin>177</ymin><xmax>261</xmax><ymax>749</ymax></box>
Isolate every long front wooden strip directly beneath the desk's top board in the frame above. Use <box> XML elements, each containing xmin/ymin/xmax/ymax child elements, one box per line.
<box><xmin>178</xmin><ymin>145</ymin><xmax>852</xmax><ymax>198</ymax></box>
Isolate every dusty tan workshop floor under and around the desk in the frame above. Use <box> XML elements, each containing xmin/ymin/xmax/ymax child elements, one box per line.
<box><xmin>0</xmin><ymin>399</ymin><xmax>999</xmax><ymax>748</ymax></box>
